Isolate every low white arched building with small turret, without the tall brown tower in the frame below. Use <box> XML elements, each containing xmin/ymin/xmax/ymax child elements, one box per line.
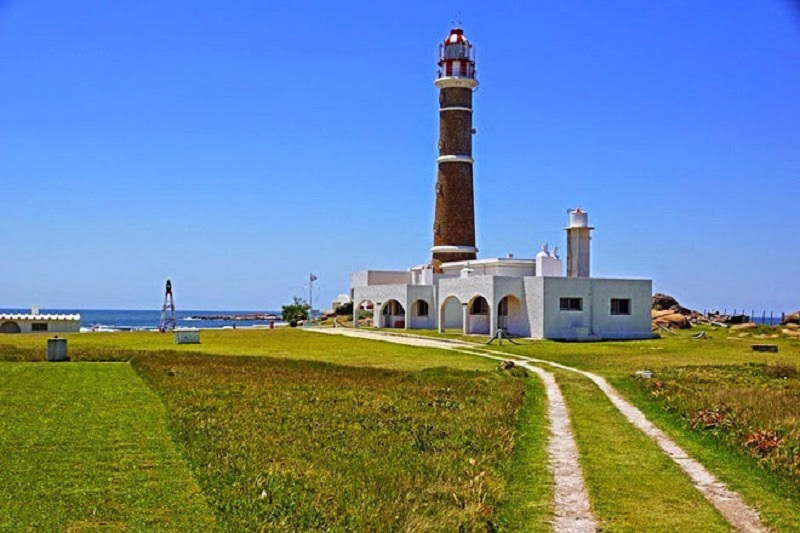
<box><xmin>350</xmin><ymin>210</ymin><xmax>652</xmax><ymax>340</ymax></box>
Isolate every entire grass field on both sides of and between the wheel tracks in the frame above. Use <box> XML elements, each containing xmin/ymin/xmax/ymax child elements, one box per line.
<box><xmin>0</xmin><ymin>329</ymin><xmax>800</xmax><ymax>531</ymax></box>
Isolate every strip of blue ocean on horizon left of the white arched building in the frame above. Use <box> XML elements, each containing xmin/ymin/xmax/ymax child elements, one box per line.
<box><xmin>0</xmin><ymin>309</ymin><xmax>281</xmax><ymax>331</ymax></box>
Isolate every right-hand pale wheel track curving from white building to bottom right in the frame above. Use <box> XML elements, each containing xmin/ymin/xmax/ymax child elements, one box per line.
<box><xmin>316</xmin><ymin>329</ymin><xmax>768</xmax><ymax>532</ymax></box>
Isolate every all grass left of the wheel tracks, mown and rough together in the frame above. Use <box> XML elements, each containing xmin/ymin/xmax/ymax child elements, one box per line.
<box><xmin>0</xmin><ymin>330</ymin><xmax>536</xmax><ymax>531</ymax></box>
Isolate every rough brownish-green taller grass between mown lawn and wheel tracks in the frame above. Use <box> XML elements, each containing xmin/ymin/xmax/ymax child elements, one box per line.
<box><xmin>133</xmin><ymin>352</ymin><xmax>532</xmax><ymax>531</ymax></box>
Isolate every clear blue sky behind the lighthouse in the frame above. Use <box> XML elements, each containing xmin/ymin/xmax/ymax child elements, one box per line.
<box><xmin>0</xmin><ymin>0</ymin><xmax>800</xmax><ymax>310</ymax></box>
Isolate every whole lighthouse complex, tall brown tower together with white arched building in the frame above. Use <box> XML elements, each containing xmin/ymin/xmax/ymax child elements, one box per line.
<box><xmin>350</xmin><ymin>28</ymin><xmax>652</xmax><ymax>340</ymax></box>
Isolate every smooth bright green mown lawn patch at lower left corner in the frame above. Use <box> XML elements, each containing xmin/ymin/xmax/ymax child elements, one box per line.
<box><xmin>0</xmin><ymin>363</ymin><xmax>214</xmax><ymax>531</ymax></box>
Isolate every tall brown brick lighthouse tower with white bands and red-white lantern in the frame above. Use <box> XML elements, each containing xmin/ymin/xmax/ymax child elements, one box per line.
<box><xmin>431</xmin><ymin>28</ymin><xmax>478</xmax><ymax>268</ymax></box>
